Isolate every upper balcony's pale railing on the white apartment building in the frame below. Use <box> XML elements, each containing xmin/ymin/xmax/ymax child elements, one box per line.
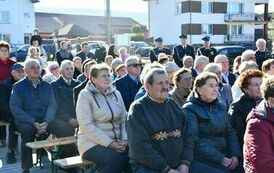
<box><xmin>225</xmin><ymin>13</ymin><xmax>256</xmax><ymax>22</ymax></box>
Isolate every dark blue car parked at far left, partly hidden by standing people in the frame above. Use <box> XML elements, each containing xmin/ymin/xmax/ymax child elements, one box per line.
<box><xmin>10</xmin><ymin>44</ymin><xmax>50</xmax><ymax>62</ymax></box>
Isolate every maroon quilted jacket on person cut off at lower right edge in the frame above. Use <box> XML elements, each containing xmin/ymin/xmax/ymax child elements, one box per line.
<box><xmin>243</xmin><ymin>100</ymin><xmax>274</xmax><ymax>173</ymax></box>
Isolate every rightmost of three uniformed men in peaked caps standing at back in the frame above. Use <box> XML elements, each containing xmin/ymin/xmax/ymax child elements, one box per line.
<box><xmin>197</xmin><ymin>36</ymin><xmax>217</xmax><ymax>62</ymax></box>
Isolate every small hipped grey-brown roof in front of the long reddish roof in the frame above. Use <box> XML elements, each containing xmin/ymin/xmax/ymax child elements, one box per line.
<box><xmin>57</xmin><ymin>24</ymin><xmax>92</xmax><ymax>37</ymax></box>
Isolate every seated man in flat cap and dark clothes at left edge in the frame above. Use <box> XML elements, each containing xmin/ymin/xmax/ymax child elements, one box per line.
<box><xmin>0</xmin><ymin>63</ymin><xmax>25</xmax><ymax>164</ymax></box>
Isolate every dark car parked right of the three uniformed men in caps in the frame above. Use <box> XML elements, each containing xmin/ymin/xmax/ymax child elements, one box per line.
<box><xmin>214</xmin><ymin>46</ymin><xmax>246</xmax><ymax>66</ymax></box>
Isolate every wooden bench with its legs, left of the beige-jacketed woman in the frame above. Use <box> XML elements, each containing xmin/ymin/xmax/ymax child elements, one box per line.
<box><xmin>26</xmin><ymin>136</ymin><xmax>77</xmax><ymax>172</ymax></box>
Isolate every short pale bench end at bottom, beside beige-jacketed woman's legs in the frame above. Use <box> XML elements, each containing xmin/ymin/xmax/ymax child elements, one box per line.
<box><xmin>54</xmin><ymin>156</ymin><xmax>93</xmax><ymax>169</ymax></box>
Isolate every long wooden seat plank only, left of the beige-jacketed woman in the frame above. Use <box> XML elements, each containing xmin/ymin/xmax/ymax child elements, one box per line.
<box><xmin>26</xmin><ymin>136</ymin><xmax>77</xmax><ymax>149</ymax></box>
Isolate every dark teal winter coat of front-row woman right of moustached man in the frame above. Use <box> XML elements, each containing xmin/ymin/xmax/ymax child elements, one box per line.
<box><xmin>183</xmin><ymin>96</ymin><xmax>241</xmax><ymax>163</ymax></box>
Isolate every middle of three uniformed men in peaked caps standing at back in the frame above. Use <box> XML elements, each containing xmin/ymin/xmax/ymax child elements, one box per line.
<box><xmin>173</xmin><ymin>34</ymin><xmax>195</xmax><ymax>68</ymax></box>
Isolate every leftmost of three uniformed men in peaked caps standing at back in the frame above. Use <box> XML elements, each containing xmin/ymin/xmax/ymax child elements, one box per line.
<box><xmin>149</xmin><ymin>37</ymin><xmax>171</xmax><ymax>63</ymax></box>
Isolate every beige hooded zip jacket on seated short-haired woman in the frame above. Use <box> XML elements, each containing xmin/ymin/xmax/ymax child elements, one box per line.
<box><xmin>76</xmin><ymin>82</ymin><xmax>127</xmax><ymax>155</ymax></box>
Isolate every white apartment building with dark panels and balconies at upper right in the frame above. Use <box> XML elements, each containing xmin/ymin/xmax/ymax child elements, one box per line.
<box><xmin>146</xmin><ymin>0</ymin><xmax>268</xmax><ymax>44</ymax></box>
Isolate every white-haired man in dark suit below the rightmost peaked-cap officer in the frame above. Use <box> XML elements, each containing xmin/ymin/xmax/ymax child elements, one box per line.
<box><xmin>214</xmin><ymin>54</ymin><xmax>236</xmax><ymax>87</ymax></box>
